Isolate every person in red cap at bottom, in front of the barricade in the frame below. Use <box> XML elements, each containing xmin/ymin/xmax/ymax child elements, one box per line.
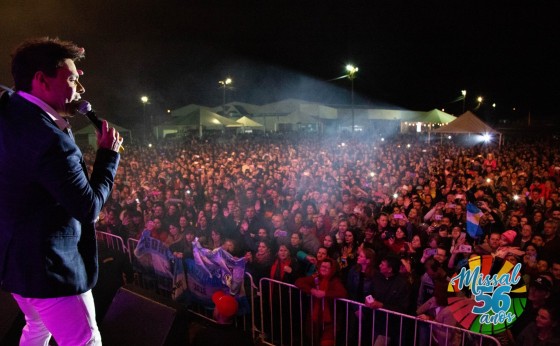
<box><xmin>192</xmin><ymin>291</ymin><xmax>254</xmax><ymax>346</ymax></box>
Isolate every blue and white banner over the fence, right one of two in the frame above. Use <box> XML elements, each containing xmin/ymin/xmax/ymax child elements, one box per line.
<box><xmin>185</xmin><ymin>241</ymin><xmax>249</xmax><ymax>314</ymax></box>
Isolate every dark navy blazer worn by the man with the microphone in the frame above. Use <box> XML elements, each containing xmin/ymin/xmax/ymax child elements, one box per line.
<box><xmin>0</xmin><ymin>93</ymin><xmax>120</xmax><ymax>298</ymax></box>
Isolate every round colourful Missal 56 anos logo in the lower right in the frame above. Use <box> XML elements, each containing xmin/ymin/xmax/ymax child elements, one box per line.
<box><xmin>447</xmin><ymin>255</ymin><xmax>527</xmax><ymax>334</ymax></box>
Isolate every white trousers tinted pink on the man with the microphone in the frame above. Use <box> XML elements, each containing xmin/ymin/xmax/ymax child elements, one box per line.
<box><xmin>12</xmin><ymin>290</ymin><xmax>101</xmax><ymax>346</ymax></box>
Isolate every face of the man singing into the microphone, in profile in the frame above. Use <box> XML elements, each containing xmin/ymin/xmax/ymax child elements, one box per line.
<box><xmin>41</xmin><ymin>59</ymin><xmax>85</xmax><ymax>112</ymax></box>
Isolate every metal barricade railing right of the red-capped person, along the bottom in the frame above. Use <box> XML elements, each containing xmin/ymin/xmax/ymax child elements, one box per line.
<box><xmin>253</xmin><ymin>278</ymin><xmax>500</xmax><ymax>346</ymax></box>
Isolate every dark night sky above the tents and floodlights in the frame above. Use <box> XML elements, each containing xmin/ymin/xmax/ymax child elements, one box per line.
<box><xmin>0</xmin><ymin>0</ymin><xmax>560</xmax><ymax>126</ymax></box>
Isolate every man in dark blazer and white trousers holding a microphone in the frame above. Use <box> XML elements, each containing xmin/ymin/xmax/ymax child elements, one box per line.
<box><xmin>0</xmin><ymin>38</ymin><xmax>122</xmax><ymax>346</ymax></box>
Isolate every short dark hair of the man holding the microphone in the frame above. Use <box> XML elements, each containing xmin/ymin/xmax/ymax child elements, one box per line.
<box><xmin>12</xmin><ymin>37</ymin><xmax>84</xmax><ymax>91</ymax></box>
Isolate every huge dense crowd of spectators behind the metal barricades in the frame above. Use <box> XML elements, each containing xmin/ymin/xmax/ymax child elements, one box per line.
<box><xmin>93</xmin><ymin>134</ymin><xmax>560</xmax><ymax>345</ymax></box>
